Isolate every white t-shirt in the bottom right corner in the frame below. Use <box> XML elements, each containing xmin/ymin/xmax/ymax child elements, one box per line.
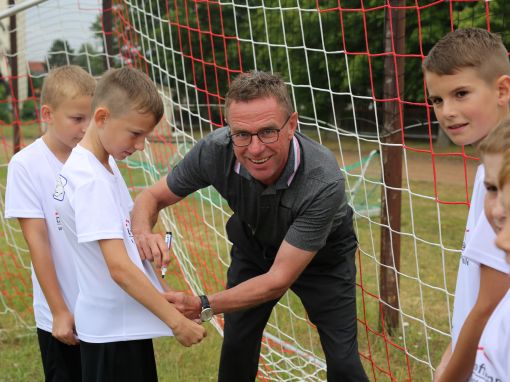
<box><xmin>469</xmin><ymin>291</ymin><xmax>510</xmax><ymax>382</ymax></box>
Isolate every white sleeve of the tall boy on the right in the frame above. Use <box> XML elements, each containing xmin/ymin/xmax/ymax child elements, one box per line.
<box><xmin>462</xmin><ymin>213</ymin><xmax>510</xmax><ymax>273</ymax></box>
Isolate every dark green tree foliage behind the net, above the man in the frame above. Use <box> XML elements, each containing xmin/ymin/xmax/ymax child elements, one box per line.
<box><xmin>58</xmin><ymin>0</ymin><xmax>508</xmax><ymax>130</ymax></box>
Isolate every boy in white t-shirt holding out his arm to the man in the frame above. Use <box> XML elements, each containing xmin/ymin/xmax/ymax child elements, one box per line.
<box><xmin>53</xmin><ymin>68</ymin><xmax>206</xmax><ymax>382</ymax></box>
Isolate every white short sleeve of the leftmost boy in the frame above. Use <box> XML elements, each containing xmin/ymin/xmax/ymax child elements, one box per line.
<box><xmin>5</xmin><ymin>161</ymin><xmax>45</xmax><ymax>219</ymax></box>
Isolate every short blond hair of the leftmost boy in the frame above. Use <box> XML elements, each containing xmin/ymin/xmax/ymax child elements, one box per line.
<box><xmin>41</xmin><ymin>65</ymin><xmax>96</xmax><ymax>108</ymax></box>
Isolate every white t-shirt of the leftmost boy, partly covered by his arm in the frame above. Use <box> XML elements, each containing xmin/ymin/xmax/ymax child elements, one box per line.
<box><xmin>5</xmin><ymin>138</ymin><xmax>78</xmax><ymax>333</ymax></box>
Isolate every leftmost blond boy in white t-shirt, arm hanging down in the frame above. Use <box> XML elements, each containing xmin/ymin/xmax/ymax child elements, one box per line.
<box><xmin>5</xmin><ymin>65</ymin><xmax>96</xmax><ymax>382</ymax></box>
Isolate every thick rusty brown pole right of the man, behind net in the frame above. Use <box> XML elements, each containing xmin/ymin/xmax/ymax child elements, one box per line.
<box><xmin>380</xmin><ymin>0</ymin><xmax>405</xmax><ymax>333</ymax></box>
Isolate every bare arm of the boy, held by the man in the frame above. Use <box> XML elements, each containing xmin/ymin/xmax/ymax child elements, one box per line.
<box><xmin>99</xmin><ymin>239</ymin><xmax>207</xmax><ymax>346</ymax></box>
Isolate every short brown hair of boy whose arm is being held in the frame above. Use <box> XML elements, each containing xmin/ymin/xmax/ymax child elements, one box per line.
<box><xmin>92</xmin><ymin>67</ymin><xmax>164</xmax><ymax>124</ymax></box>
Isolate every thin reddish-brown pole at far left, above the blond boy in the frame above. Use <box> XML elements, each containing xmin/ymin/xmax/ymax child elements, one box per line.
<box><xmin>9</xmin><ymin>0</ymin><xmax>21</xmax><ymax>154</ymax></box>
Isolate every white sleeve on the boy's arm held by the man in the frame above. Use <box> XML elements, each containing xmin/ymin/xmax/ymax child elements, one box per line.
<box><xmin>73</xmin><ymin>178</ymin><xmax>124</xmax><ymax>243</ymax></box>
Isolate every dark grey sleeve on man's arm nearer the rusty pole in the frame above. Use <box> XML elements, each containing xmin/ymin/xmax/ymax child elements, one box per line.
<box><xmin>285</xmin><ymin>180</ymin><xmax>346</xmax><ymax>251</ymax></box>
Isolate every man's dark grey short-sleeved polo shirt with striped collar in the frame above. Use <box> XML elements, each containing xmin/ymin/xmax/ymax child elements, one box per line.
<box><xmin>167</xmin><ymin>127</ymin><xmax>356</xmax><ymax>253</ymax></box>
